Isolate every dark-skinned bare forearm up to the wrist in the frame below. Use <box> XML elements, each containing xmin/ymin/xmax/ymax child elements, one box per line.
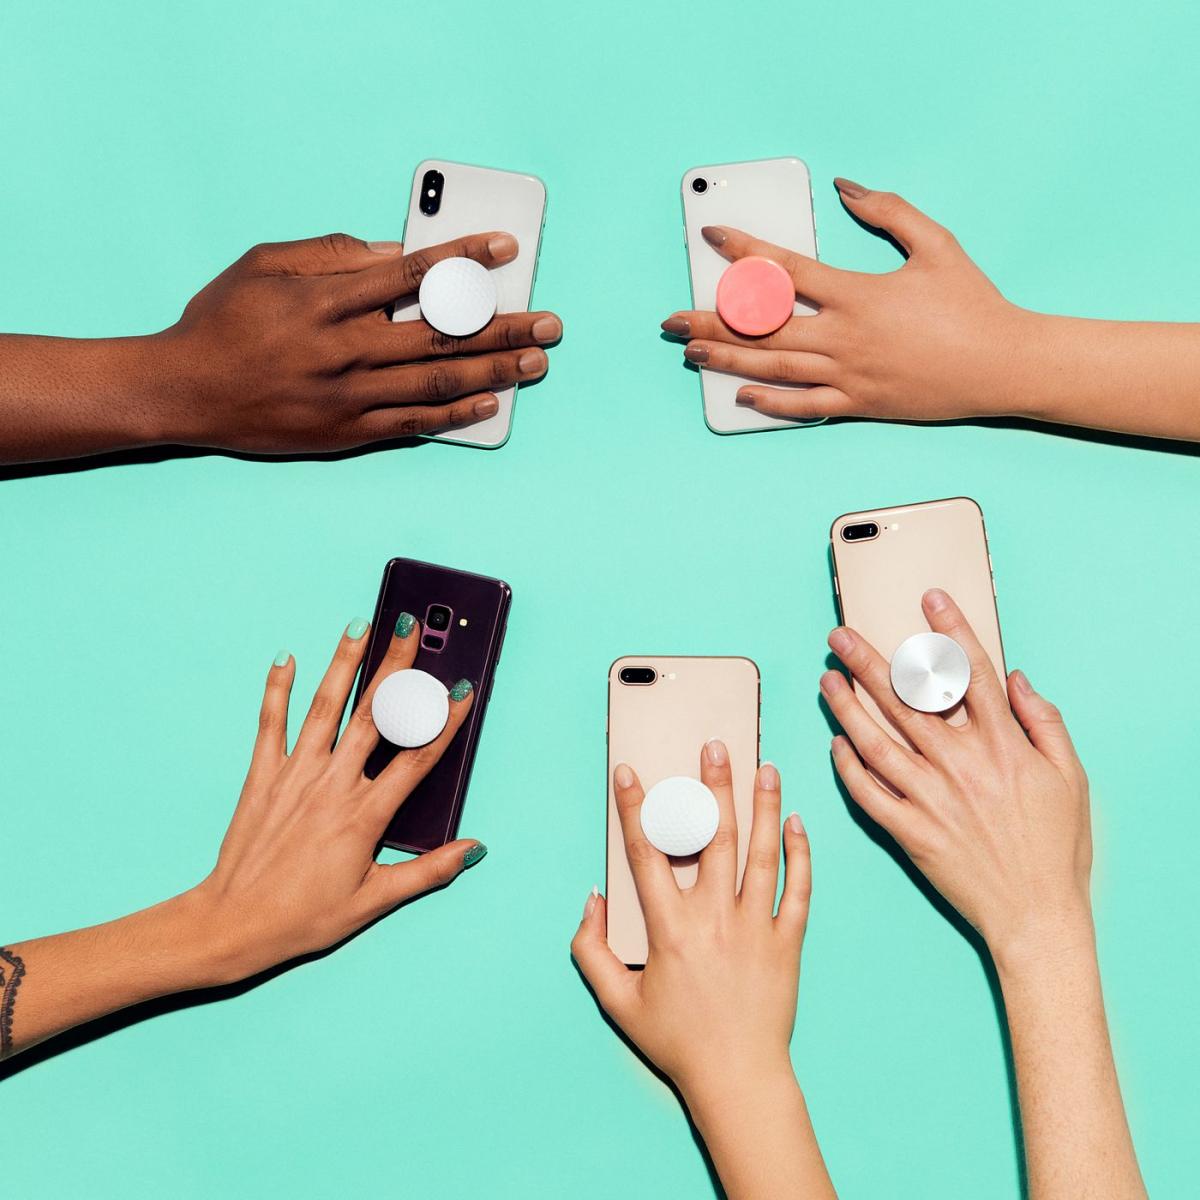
<box><xmin>0</xmin><ymin>334</ymin><xmax>187</xmax><ymax>463</ymax></box>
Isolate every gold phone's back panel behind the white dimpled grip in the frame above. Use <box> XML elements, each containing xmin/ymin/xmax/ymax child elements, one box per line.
<box><xmin>605</xmin><ymin>655</ymin><xmax>758</xmax><ymax>966</ymax></box>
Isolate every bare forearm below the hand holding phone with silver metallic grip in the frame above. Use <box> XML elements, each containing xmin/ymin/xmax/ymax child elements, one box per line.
<box><xmin>996</xmin><ymin>918</ymin><xmax>1146</xmax><ymax>1200</ymax></box>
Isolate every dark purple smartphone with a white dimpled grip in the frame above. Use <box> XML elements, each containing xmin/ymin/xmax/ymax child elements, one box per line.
<box><xmin>354</xmin><ymin>558</ymin><xmax>512</xmax><ymax>853</ymax></box>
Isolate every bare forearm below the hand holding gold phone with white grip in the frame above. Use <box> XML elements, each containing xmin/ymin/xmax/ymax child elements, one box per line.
<box><xmin>684</xmin><ymin>1064</ymin><xmax>836</xmax><ymax>1200</ymax></box>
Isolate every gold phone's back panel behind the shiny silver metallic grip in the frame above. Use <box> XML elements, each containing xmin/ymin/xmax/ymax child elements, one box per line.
<box><xmin>830</xmin><ymin>497</ymin><xmax>1006</xmax><ymax>742</ymax></box>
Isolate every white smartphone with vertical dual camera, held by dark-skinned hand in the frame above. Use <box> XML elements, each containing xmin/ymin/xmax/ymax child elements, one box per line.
<box><xmin>391</xmin><ymin>158</ymin><xmax>546</xmax><ymax>449</ymax></box>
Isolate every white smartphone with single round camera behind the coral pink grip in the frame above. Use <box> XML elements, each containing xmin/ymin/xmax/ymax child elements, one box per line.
<box><xmin>683</xmin><ymin>158</ymin><xmax>821</xmax><ymax>433</ymax></box>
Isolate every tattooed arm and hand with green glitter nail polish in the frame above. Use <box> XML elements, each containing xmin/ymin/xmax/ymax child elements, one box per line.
<box><xmin>0</xmin><ymin>614</ymin><xmax>487</xmax><ymax>1058</ymax></box>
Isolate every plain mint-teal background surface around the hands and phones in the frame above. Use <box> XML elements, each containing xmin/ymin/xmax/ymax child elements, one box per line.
<box><xmin>0</xmin><ymin>0</ymin><xmax>1200</xmax><ymax>1198</ymax></box>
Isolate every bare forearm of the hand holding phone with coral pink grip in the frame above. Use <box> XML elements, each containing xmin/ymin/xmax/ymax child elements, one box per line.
<box><xmin>996</xmin><ymin>310</ymin><xmax>1200</xmax><ymax>442</ymax></box>
